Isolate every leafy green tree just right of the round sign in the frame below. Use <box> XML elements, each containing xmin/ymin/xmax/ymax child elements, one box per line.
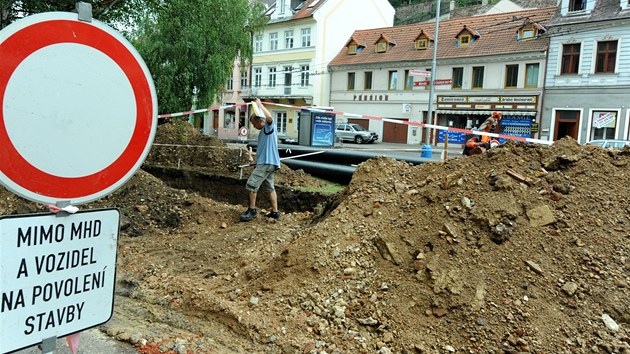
<box><xmin>133</xmin><ymin>0</ymin><xmax>266</xmax><ymax>112</ymax></box>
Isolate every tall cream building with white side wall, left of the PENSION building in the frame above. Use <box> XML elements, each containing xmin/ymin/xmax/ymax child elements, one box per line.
<box><xmin>219</xmin><ymin>0</ymin><xmax>394</xmax><ymax>139</ymax></box>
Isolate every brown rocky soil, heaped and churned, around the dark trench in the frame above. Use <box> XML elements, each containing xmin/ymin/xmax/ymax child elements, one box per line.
<box><xmin>0</xmin><ymin>124</ymin><xmax>630</xmax><ymax>354</ymax></box>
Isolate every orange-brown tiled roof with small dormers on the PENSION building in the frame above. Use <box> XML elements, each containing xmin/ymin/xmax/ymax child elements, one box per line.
<box><xmin>330</xmin><ymin>7</ymin><xmax>557</xmax><ymax>66</ymax></box>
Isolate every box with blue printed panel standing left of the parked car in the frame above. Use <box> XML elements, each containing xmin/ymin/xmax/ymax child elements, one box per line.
<box><xmin>298</xmin><ymin>107</ymin><xmax>336</xmax><ymax>147</ymax></box>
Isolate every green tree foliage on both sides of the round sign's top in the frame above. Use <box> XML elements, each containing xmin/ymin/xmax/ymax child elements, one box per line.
<box><xmin>0</xmin><ymin>0</ymin><xmax>266</xmax><ymax>112</ymax></box>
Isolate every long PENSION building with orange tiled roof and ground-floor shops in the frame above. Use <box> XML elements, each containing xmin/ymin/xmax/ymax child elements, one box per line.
<box><xmin>329</xmin><ymin>7</ymin><xmax>557</xmax><ymax>144</ymax></box>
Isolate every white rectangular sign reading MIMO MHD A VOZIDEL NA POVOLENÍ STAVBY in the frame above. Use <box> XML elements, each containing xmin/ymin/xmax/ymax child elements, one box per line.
<box><xmin>0</xmin><ymin>209</ymin><xmax>120</xmax><ymax>353</ymax></box>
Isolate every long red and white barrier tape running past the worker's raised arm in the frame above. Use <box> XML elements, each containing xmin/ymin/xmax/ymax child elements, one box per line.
<box><xmin>158</xmin><ymin>102</ymin><xmax>553</xmax><ymax>145</ymax></box>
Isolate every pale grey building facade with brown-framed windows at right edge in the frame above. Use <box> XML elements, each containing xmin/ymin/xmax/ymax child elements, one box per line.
<box><xmin>542</xmin><ymin>0</ymin><xmax>630</xmax><ymax>143</ymax></box>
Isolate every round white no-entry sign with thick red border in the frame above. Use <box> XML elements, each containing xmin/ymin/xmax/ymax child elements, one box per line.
<box><xmin>0</xmin><ymin>12</ymin><xmax>157</xmax><ymax>205</ymax></box>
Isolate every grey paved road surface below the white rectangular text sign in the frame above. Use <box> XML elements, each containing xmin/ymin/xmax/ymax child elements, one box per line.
<box><xmin>14</xmin><ymin>328</ymin><xmax>138</xmax><ymax>354</ymax></box>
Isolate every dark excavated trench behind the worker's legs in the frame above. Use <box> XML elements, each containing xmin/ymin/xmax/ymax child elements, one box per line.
<box><xmin>142</xmin><ymin>164</ymin><xmax>339</xmax><ymax>214</ymax></box>
